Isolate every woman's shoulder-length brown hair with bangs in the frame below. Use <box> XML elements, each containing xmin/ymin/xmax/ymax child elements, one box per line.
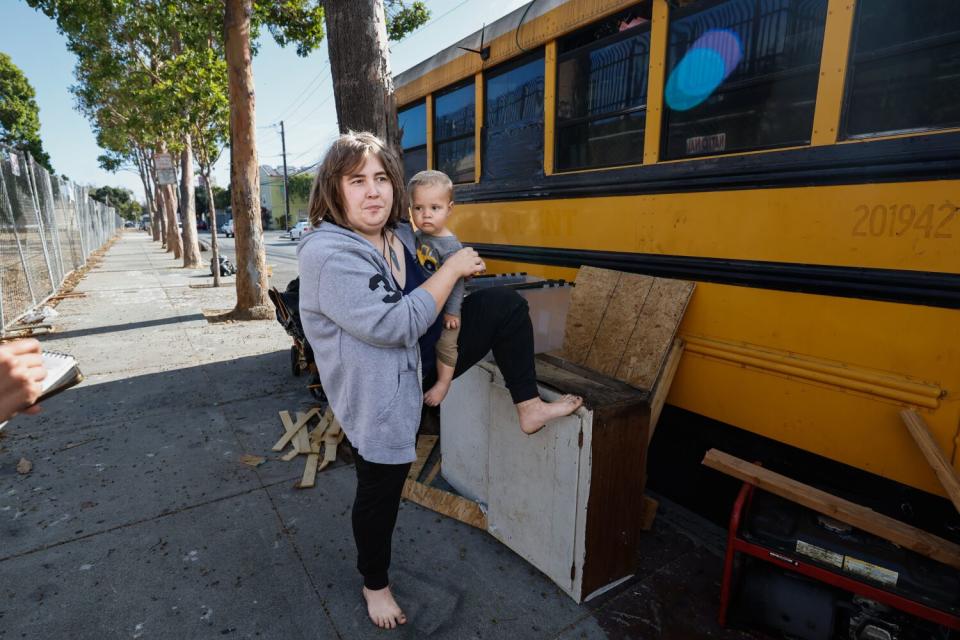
<box><xmin>309</xmin><ymin>131</ymin><xmax>406</xmax><ymax>229</ymax></box>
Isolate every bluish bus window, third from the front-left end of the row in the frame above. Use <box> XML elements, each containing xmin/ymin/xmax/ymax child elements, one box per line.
<box><xmin>481</xmin><ymin>50</ymin><xmax>543</xmax><ymax>180</ymax></box>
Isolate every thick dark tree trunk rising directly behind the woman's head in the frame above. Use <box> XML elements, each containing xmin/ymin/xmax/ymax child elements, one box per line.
<box><xmin>323</xmin><ymin>0</ymin><xmax>400</xmax><ymax>151</ymax></box>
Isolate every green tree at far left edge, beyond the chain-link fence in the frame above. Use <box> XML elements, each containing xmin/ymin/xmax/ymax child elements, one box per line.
<box><xmin>0</xmin><ymin>53</ymin><xmax>54</xmax><ymax>173</ymax></box>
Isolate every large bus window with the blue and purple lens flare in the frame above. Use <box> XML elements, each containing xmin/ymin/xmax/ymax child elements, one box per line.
<box><xmin>663</xmin><ymin>0</ymin><xmax>827</xmax><ymax>159</ymax></box>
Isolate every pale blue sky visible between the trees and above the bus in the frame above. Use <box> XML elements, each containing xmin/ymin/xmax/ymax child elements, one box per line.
<box><xmin>0</xmin><ymin>0</ymin><xmax>527</xmax><ymax>199</ymax></box>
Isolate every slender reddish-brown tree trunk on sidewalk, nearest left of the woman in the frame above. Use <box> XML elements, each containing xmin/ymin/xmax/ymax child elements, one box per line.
<box><xmin>224</xmin><ymin>0</ymin><xmax>273</xmax><ymax>319</ymax></box>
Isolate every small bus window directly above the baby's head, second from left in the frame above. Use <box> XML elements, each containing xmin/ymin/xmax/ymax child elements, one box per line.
<box><xmin>433</xmin><ymin>82</ymin><xmax>476</xmax><ymax>183</ymax></box>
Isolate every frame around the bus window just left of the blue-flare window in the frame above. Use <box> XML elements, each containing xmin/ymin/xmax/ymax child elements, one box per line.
<box><xmin>553</xmin><ymin>14</ymin><xmax>656</xmax><ymax>174</ymax></box>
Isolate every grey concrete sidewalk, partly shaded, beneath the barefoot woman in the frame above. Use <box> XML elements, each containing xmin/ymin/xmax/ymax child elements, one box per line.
<box><xmin>0</xmin><ymin>232</ymin><xmax>747</xmax><ymax>640</ymax></box>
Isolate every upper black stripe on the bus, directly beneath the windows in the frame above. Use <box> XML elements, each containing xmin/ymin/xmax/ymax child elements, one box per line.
<box><xmin>455</xmin><ymin>132</ymin><xmax>960</xmax><ymax>203</ymax></box>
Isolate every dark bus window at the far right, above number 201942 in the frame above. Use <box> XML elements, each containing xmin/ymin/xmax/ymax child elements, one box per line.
<box><xmin>843</xmin><ymin>0</ymin><xmax>960</xmax><ymax>138</ymax></box>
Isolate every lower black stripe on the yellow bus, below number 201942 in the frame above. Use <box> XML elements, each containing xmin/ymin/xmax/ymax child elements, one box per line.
<box><xmin>466</xmin><ymin>242</ymin><xmax>960</xmax><ymax>309</ymax></box>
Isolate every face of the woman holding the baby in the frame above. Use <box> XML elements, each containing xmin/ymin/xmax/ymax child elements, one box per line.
<box><xmin>340</xmin><ymin>154</ymin><xmax>393</xmax><ymax>239</ymax></box>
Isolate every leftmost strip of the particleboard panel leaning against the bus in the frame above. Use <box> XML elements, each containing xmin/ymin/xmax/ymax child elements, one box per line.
<box><xmin>563</xmin><ymin>267</ymin><xmax>621</xmax><ymax>364</ymax></box>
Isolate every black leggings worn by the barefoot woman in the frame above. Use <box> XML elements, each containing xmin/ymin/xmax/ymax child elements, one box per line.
<box><xmin>352</xmin><ymin>288</ymin><xmax>538</xmax><ymax>589</ymax></box>
